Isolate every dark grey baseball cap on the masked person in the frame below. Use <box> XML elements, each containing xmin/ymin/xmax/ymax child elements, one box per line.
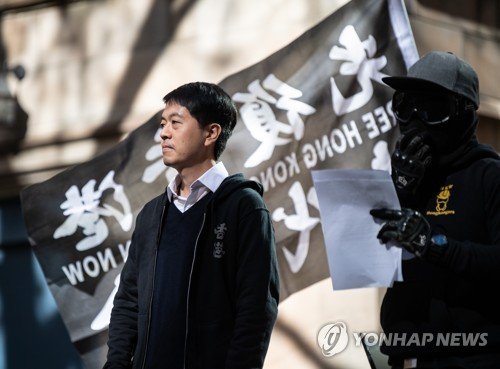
<box><xmin>382</xmin><ymin>51</ymin><xmax>479</xmax><ymax>109</ymax></box>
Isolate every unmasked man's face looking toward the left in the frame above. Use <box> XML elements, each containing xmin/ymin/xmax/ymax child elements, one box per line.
<box><xmin>160</xmin><ymin>102</ymin><xmax>209</xmax><ymax>171</ymax></box>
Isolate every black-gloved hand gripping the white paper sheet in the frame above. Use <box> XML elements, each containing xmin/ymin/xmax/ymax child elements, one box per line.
<box><xmin>370</xmin><ymin>208</ymin><xmax>432</xmax><ymax>257</ymax></box>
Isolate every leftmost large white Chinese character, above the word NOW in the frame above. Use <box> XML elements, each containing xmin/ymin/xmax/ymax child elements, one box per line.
<box><xmin>53</xmin><ymin>170</ymin><xmax>133</xmax><ymax>251</ymax></box>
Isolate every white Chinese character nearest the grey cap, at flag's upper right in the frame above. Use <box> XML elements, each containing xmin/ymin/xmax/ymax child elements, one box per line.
<box><xmin>329</xmin><ymin>25</ymin><xmax>387</xmax><ymax>115</ymax></box>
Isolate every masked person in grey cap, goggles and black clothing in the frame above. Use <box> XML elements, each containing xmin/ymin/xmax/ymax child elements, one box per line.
<box><xmin>371</xmin><ymin>52</ymin><xmax>500</xmax><ymax>368</ymax></box>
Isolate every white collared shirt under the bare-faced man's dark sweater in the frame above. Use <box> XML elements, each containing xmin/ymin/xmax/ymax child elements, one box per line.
<box><xmin>167</xmin><ymin>161</ymin><xmax>229</xmax><ymax>213</ymax></box>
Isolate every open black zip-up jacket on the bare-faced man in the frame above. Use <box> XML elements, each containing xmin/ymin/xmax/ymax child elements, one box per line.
<box><xmin>104</xmin><ymin>174</ymin><xmax>279</xmax><ymax>369</ymax></box>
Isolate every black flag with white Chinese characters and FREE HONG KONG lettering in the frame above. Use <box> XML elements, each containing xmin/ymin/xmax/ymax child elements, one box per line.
<box><xmin>22</xmin><ymin>0</ymin><xmax>418</xmax><ymax>369</ymax></box>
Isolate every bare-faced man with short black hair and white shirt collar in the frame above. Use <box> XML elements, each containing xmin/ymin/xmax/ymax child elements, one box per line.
<box><xmin>104</xmin><ymin>82</ymin><xmax>279</xmax><ymax>369</ymax></box>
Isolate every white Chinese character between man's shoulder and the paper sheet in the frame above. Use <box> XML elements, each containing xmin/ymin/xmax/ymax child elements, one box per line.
<box><xmin>273</xmin><ymin>181</ymin><xmax>320</xmax><ymax>273</ymax></box>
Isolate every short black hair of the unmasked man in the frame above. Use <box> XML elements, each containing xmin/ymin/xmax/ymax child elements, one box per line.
<box><xmin>163</xmin><ymin>82</ymin><xmax>238</xmax><ymax>160</ymax></box>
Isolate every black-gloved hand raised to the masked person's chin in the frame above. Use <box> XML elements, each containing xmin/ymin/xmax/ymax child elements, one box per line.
<box><xmin>391</xmin><ymin>131</ymin><xmax>432</xmax><ymax>200</ymax></box>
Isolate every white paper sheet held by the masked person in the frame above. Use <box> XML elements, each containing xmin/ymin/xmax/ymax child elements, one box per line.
<box><xmin>312</xmin><ymin>169</ymin><xmax>403</xmax><ymax>290</ymax></box>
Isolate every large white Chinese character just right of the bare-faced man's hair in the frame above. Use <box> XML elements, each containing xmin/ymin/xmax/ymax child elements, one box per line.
<box><xmin>233</xmin><ymin>74</ymin><xmax>316</xmax><ymax>168</ymax></box>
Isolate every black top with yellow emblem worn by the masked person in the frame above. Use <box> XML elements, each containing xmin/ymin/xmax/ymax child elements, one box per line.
<box><xmin>381</xmin><ymin>141</ymin><xmax>500</xmax><ymax>360</ymax></box>
